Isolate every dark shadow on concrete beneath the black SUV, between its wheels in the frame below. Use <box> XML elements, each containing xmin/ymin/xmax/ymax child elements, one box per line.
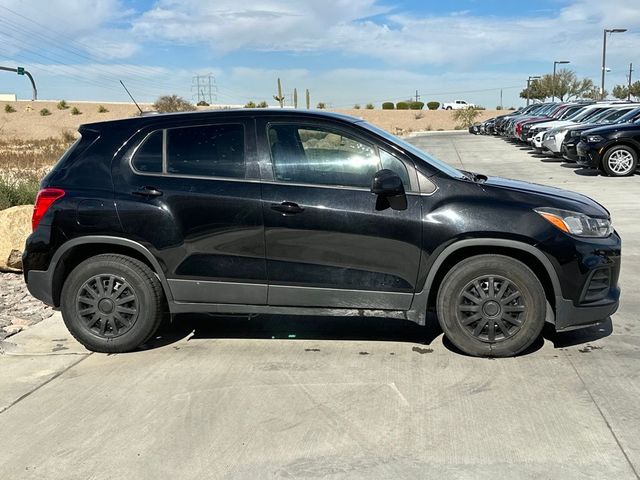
<box><xmin>143</xmin><ymin>314</ymin><xmax>442</xmax><ymax>349</ymax></box>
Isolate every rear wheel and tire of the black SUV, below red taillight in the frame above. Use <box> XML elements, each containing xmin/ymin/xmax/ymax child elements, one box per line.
<box><xmin>60</xmin><ymin>254</ymin><xmax>164</xmax><ymax>353</ymax></box>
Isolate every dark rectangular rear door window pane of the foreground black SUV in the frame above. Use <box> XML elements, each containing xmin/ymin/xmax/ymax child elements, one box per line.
<box><xmin>167</xmin><ymin>125</ymin><xmax>245</xmax><ymax>178</ymax></box>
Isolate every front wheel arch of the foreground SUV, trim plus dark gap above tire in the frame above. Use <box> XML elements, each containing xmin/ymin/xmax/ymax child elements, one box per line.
<box><xmin>409</xmin><ymin>238</ymin><xmax>562</xmax><ymax>324</ymax></box>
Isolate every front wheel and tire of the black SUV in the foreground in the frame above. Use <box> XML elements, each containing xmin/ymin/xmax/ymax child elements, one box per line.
<box><xmin>437</xmin><ymin>255</ymin><xmax>547</xmax><ymax>357</ymax></box>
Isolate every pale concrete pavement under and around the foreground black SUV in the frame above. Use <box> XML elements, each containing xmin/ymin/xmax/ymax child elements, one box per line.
<box><xmin>0</xmin><ymin>133</ymin><xmax>640</xmax><ymax>480</ymax></box>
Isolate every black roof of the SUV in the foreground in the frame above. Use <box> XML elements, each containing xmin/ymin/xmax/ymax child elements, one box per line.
<box><xmin>80</xmin><ymin>108</ymin><xmax>362</xmax><ymax>130</ymax></box>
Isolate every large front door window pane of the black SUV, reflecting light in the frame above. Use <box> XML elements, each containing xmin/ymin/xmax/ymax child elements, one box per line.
<box><xmin>269</xmin><ymin>125</ymin><xmax>380</xmax><ymax>188</ymax></box>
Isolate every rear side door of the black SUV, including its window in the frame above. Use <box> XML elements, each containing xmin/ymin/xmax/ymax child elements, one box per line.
<box><xmin>113</xmin><ymin>118</ymin><xmax>267</xmax><ymax>304</ymax></box>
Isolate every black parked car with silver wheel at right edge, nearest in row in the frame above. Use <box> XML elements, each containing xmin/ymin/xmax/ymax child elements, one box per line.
<box><xmin>576</xmin><ymin>122</ymin><xmax>640</xmax><ymax>177</ymax></box>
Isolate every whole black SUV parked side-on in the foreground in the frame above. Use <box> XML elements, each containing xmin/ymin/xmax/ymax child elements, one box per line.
<box><xmin>23</xmin><ymin>109</ymin><xmax>620</xmax><ymax>356</ymax></box>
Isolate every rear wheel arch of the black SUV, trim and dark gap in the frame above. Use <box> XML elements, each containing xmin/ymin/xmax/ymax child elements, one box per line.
<box><xmin>49</xmin><ymin>235</ymin><xmax>173</xmax><ymax>306</ymax></box>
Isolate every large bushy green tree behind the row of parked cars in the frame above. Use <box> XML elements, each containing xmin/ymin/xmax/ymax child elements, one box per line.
<box><xmin>520</xmin><ymin>68</ymin><xmax>596</xmax><ymax>101</ymax></box>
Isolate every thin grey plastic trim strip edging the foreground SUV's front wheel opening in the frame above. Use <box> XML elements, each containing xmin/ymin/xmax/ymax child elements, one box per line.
<box><xmin>407</xmin><ymin>238</ymin><xmax>562</xmax><ymax>325</ymax></box>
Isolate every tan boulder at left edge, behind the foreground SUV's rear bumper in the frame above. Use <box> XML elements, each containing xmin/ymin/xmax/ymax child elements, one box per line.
<box><xmin>0</xmin><ymin>205</ymin><xmax>33</xmax><ymax>272</ymax></box>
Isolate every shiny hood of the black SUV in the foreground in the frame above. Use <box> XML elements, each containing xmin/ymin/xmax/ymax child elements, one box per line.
<box><xmin>480</xmin><ymin>177</ymin><xmax>609</xmax><ymax>218</ymax></box>
